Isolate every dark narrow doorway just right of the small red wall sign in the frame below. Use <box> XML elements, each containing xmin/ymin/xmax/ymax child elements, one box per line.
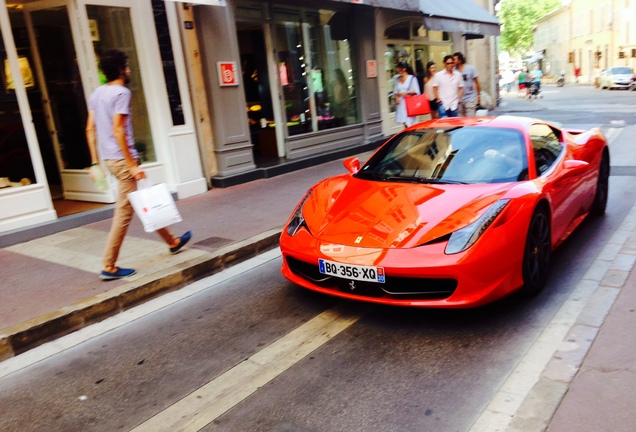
<box><xmin>236</xmin><ymin>22</ymin><xmax>279</xmax><ymax>166</ymax></box>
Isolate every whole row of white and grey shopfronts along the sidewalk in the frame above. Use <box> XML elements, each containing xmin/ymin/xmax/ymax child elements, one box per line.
<box><xmin>0</xmin><ymin>0</ymin><xmax>499</xmax><ymax>232</ymax></box>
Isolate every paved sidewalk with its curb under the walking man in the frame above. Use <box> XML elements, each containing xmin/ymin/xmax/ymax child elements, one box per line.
<box><xmin>0</xmin><ymin>153</ymin><xmax>369</xmax><ymax>361</ymax></box>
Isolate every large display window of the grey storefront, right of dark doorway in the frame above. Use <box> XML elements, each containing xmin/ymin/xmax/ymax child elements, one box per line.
<box><xmin>274</xmin><ymin>7</ymin><xmax>359</xmax><ymax>135</ymax></box>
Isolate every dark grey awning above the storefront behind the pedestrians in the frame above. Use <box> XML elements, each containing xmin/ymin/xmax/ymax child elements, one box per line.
<box><xmin>330</xmin><ymin>0</ymin><xmax>499</xmax><ymax>36</ymax></box>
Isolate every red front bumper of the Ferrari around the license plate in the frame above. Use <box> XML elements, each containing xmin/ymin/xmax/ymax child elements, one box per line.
<box><xmin>280</xmin><ymin>228</ymin><xmax>525</xmax><ymax>308</ymax></box>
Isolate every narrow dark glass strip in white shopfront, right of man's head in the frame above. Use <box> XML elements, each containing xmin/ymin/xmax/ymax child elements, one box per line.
<box><xmin>152</xmin><ymin>0</ymin><xmax>185</xmax><ymax>126</ymax></box>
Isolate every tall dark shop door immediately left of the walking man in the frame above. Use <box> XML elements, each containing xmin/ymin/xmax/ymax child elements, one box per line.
<box><xmin>25</xmin><ymin>0</ymin><xmax>114</xmax><ymax>202</ymax></box>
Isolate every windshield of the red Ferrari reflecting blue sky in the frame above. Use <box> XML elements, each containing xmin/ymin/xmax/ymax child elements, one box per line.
<box><xmin>356</xmin><ymin>126</ymin><xmax>528</xmax><ymax>184</ymax></box>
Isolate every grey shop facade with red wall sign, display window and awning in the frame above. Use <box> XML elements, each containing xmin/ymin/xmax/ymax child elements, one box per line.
<box><xmin>189</xmin><ymin>0</ymin><xmax>499</xmax><ymax>186</ymax></box>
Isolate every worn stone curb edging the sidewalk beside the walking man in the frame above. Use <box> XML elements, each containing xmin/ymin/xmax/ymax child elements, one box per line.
<box><xmin>0</xmin><ymin>228</ymin><xmax>282</xmax><ymax>361</ymax></box>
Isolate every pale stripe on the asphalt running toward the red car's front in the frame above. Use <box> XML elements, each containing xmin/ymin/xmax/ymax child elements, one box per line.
<box><xmin>132</xmin><ymin>305</ymin><xmax>370</xmax><ymax>432</ymax></box>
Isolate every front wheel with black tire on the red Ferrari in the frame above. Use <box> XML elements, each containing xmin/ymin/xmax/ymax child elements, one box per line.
<box><xmin>521</xmin><ymin>206</ymin><xmax>552</xmax><ymax>296</ymax></box>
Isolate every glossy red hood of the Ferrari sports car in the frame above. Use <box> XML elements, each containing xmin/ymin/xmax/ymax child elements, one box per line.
<box><xmin>303</xmin><ymin>175</ymin><xmax>514</xmax><ymax>248</ymax></box>
